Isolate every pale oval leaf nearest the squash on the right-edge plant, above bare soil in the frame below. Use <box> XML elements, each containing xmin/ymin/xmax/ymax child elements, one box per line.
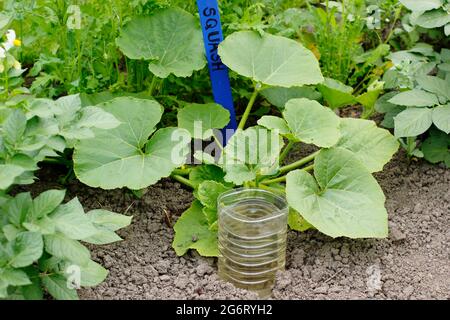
<box><xmin>394</xmin><ymin>108</ymin><xmax>433</xmax><ymax>137</ymax></box>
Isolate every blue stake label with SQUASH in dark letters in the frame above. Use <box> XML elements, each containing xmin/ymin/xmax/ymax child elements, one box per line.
<box><xmin>197</xmin><ymin>0</ymin><xmax>237</xmax><ymax>140</ymax></box>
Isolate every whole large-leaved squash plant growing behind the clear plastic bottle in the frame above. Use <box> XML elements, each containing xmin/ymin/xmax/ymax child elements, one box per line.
<box><xmin>68</xmin><ymin>9</ymin><xmax>398</xmax><ymax>256</ymax></box>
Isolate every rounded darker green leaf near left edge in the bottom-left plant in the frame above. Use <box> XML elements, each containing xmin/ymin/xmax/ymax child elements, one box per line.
<box><xmin>8</xmin><ymin>232</ymin><xmax>44</xmax><ymax>268</ymax></box>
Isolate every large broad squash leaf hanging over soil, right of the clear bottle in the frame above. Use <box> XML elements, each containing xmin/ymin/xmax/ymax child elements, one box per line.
<box><xmin>286</xmin><ymin>148</ymin><xmax>388</xmax><ymax>238</ymax></box>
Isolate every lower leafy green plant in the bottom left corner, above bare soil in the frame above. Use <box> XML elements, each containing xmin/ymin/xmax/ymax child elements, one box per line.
<box><xmin>0</xmin><ymin>190</ymin><xmax>131</xmax><ymax>300</ymax></box>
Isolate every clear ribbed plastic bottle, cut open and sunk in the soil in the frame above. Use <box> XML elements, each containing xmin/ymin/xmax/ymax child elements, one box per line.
<box><xmin>218</xmin><ymin>189</ymin><xmax>288</xmax><ymax>298</ymax></box>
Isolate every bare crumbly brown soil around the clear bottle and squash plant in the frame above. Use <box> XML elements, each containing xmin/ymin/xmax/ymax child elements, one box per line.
<box><xmin>22</xmin><ymin>150</ymin><xmax>450</xmax><ymax>299</ymax></box>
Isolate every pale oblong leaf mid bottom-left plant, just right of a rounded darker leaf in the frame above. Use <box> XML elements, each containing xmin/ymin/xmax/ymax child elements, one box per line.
<box><xmin>44</xmin><ymin>233</ymin><xmax>91</xmax><ymax>266</ymax></box>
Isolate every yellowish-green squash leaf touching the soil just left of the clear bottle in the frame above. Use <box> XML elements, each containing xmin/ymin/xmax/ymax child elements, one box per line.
<box><xmin>172</xmin><ymin>200</ymin><xmax>219</xmax><ymax>257</ymax></box>
